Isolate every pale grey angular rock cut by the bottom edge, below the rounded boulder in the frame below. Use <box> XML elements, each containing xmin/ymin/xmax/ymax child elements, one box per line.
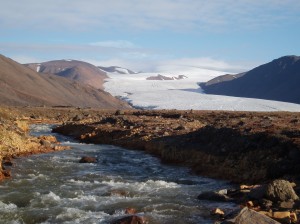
<box><xmin>234</xmin><ymin>208</ymin><xmax>280</xmax><ymax>224</ymax></box>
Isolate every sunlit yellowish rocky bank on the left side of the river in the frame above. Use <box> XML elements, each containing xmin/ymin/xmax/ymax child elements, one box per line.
<box><xmin>0</xmin><ymin>106</ymin><xmax>113</xmax><ymax>181</ymax></box>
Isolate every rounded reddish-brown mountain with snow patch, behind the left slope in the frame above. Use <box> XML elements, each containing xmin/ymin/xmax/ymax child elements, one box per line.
<box><xmin>26</xmin><ymin>60</ymin><xmax>107</xmax><ymax>89</ymax></box>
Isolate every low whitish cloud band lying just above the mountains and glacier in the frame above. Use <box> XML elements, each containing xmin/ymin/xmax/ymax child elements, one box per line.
<box><xmin>0</xmin><ymin>40</ymin><xmax>258</xmax><ymax>73</ymax></box>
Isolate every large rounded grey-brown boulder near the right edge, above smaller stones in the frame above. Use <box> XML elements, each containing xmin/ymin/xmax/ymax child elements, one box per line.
<box><xmin>265</xmin><ymin>180</ymin><xmax>299</xmax><ymax>202</ymax></box>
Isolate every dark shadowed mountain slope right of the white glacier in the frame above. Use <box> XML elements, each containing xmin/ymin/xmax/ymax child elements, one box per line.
<box><xmin>200</xmin><ymin>56</ymin><xmax>300</xmax><ymax>104</ymax></box>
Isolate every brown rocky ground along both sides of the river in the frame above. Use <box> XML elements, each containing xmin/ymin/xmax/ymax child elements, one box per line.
<box><xmin>0</xmin><ymin>108</ymin><xmax>300</xmax><ymax>223</ymax></box>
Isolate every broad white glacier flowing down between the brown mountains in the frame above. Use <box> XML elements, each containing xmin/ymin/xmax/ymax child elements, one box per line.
<box><xmin>104</xmin><ymin>68</ymin><xmax>300</xmax><ymax>111</ymax></box>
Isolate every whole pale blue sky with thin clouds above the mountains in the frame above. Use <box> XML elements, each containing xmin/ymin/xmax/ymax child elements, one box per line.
<box><xmin>0</xmin><ymin>0</ymin><xmax>300</xmax><ymax>72</ymax></box>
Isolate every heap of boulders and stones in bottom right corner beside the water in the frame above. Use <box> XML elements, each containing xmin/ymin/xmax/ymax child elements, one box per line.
<box><xmin>202</xmin><ymin>180</ymin><xmax>300</xmax><ymax>224</ymax></box>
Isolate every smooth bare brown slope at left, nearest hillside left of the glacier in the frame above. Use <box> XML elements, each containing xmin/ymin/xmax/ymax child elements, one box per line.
<box><xmin>0</xmin><ymin>55</ymin><xmax>127</xmax><ymax>109</ymax></box>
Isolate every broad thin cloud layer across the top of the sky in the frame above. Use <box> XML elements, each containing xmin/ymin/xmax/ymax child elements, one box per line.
<box><xmin>0</xmin><ymin>0</ymin><xmax>300</xmax><ymax>32</ymax></box>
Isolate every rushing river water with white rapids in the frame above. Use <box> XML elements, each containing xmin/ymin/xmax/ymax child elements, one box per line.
<box><xmin>0</xmin><ymin>125</ymin><xmax>235</xmax><ymax>224</ymax></box>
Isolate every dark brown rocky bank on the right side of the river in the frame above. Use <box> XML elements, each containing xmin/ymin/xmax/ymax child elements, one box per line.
<box><xmin>54</xmin><ymin>111</ymin><xmax>300</xmax><ymax>184</ymax></box>
